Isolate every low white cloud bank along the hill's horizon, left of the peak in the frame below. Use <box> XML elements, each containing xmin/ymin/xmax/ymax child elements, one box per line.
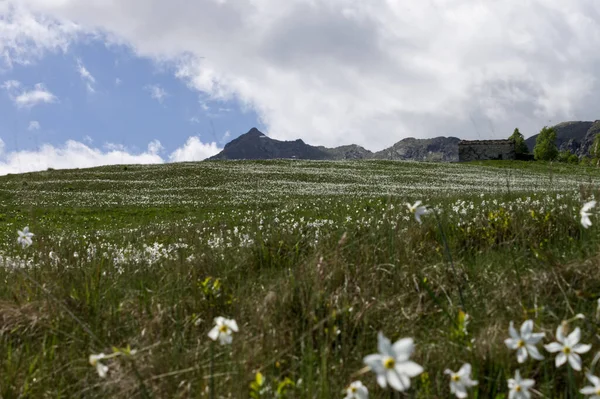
<box><xmin>0</xmin><ymin>137</ymin><xmax>221</xmax><ymax>175</ymax></box>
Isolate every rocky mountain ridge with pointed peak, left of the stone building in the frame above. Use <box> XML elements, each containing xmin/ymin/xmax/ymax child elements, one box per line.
<box><xmin>209</xmin><ymin>128</ymin><xmax>460</xmax><ymax>161</ymax></box>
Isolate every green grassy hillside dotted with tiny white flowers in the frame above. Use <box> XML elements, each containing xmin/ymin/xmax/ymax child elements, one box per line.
<box><xmin>0</xmin><ymin>161</ymin><xmax>600</xmax><ymax>398</ymax></box>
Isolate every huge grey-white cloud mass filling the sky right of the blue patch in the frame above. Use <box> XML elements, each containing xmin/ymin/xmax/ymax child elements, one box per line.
<box><xmin>12</xmin><ymin>0</ymin><xmax>600</xmax><ymax>150</ymax></box>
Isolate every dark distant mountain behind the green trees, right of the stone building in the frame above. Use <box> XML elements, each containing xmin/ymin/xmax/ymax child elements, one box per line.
<box><xmin>525</xmin><ymin>121</ymin><xmax>600</xmax><ymax>156</ymax></box>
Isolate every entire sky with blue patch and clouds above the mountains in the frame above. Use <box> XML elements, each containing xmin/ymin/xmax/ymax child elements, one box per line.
<box><xmin>0</xmin><ymin>0</ymin><xmax>600</xmax><ymax>175</ymax></box>
